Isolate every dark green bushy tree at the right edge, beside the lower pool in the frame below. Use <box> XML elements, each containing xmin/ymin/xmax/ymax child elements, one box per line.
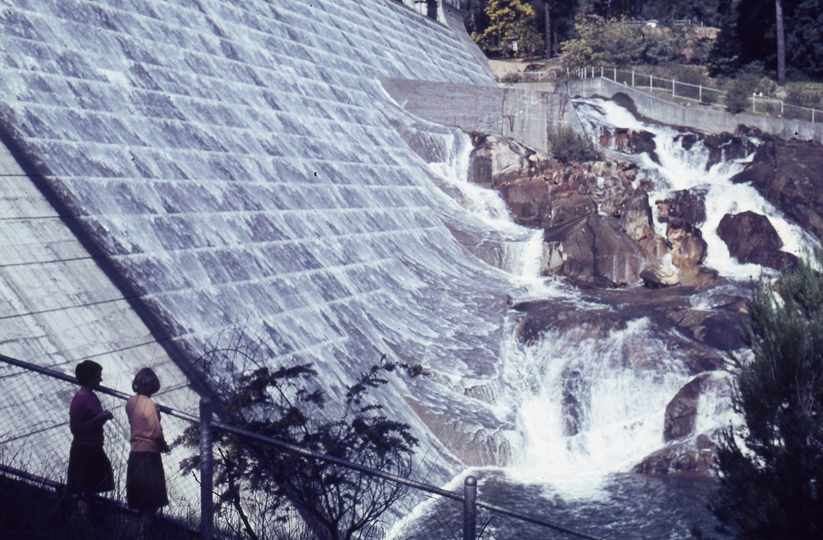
<box><xmin>711</xmin><ymin>254</ymin><xmax>823</xmax><ymax>540</ymax></box>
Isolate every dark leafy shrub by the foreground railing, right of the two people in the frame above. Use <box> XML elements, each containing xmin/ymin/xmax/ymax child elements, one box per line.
<box><xmin>182</xmin><ymin>333</ymin><xmax>422</xmax><ymax>540</ymax></box>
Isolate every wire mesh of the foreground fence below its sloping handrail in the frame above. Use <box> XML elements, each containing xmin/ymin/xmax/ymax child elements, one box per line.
<box><xmin>0</xmin><ymin>355</ymin><xmax>597</xmax><ymax>540</ymax></box>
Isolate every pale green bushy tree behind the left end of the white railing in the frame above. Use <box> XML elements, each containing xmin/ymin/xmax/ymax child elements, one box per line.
<box><xmin>562</xmin><ymin>15</ymin><xmax>643</xmax><ymax>68</ymax></box>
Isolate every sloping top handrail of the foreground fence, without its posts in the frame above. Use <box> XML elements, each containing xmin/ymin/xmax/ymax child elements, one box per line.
<box><xmin>0</xmin><ymin>354</ymin><xmax>602</xmax><ymax>540</ymax></box>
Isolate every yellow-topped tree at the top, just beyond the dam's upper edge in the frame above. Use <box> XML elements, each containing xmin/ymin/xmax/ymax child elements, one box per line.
<box><xmin>472</xmin><ymin>0</ymin><xmax>543</xmax><ymax>57</ymax></box>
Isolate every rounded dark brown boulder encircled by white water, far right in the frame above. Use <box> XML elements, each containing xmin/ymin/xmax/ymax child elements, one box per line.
<box><xmin>717</xmin><ymin>212</ymin><xmax>797</xmax><ymax>270</ymax></box>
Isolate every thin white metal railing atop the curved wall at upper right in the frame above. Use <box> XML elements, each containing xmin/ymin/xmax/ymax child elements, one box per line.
<box><xmin>566</xmin><ymin>67</ymin><xmax>823</xmax><ymax>123</ymax></box>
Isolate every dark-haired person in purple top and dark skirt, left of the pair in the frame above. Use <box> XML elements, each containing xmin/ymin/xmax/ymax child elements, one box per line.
<box><xmin>66</xmin><ymin>360</ymin><xmax>114</xmax><ymax>517</ymax></box>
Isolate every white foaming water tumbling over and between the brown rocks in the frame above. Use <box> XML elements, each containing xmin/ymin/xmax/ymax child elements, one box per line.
<box><xmin>422</xmin><ymin>100</ymin><xmax>816</xmax><ymax>510</ymax></box>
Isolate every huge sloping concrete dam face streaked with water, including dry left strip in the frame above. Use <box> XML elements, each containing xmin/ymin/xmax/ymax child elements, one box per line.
<box><xmin>0</xmin><ymin>0</ymin><xmax>524</xmax><ymax>492</ymax></box>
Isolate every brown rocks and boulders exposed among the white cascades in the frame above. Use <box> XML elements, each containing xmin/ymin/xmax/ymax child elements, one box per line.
<box><xmin>469</xmin><ymin>107</ymin><xmax>823</xmax><ymax>474</ymax></box>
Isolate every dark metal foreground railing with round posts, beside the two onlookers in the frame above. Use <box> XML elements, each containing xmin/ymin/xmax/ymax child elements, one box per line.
<box><xmin>0</xmin><ymin>355</ymin><xmax>601</xmax><ymax>540</ymax></box>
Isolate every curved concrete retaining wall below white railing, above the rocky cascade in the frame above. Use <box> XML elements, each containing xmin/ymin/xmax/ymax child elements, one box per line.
<box><xmin>558</xmin><ymin>77</ymin><xmax>823</xmax><ymax>142</ymax></box>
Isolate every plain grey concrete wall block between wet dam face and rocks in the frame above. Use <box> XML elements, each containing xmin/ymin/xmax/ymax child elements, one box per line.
<box><xmin>381</xmin><ymin>79</ymin><xmax>579</xmax><ymax>153</ymax></box>
